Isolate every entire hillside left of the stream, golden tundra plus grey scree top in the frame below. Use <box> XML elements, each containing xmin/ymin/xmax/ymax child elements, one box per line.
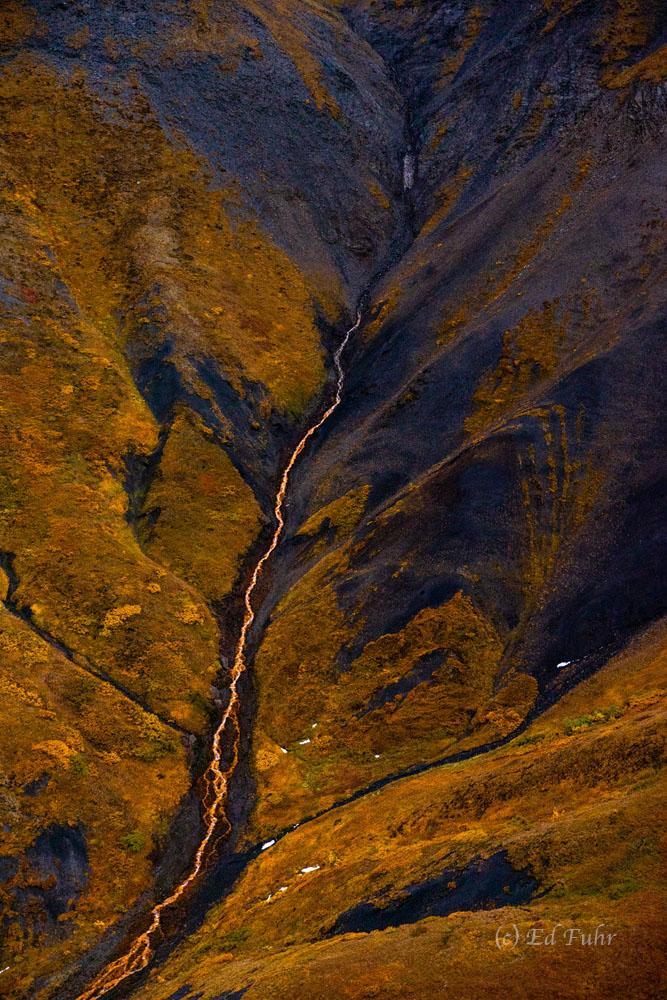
<box><xmin>0</xmin><ymin>0</ymin><xmax>403</xmax><ymax>991</ymax></box>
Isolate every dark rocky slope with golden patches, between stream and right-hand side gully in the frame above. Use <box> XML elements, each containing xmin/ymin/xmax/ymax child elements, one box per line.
<box><xmin>248</xmin><ymin>3</ymin><xmax>667</xmax><ymax>825</ymax></box>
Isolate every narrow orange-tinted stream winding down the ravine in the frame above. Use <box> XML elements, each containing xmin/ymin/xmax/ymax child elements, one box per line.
<box><xmin>72</xmin><ymin>311</ymin><xmax>361</xmax><ymax>1000</ymax></box>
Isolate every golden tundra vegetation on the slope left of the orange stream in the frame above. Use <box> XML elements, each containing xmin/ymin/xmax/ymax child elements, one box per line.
<box><xmin>0</xmin><ymin>2</ymin><xmax>370</xmax><ymax>995</ymax></box>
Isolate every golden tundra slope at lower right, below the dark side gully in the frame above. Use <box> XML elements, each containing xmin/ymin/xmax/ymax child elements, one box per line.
<box><xmin>137</xmin><ymin>622</ymin><xmax>667</xmax><ymax>1000</ymax></box>
